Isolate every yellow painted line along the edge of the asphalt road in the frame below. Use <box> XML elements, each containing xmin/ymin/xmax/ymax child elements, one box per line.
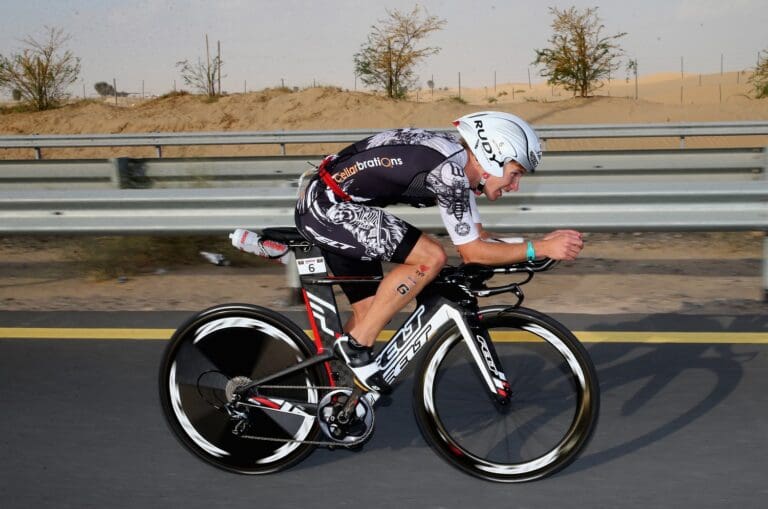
<box><xmin>0</xmin><ymin>327</ymin><xmax>768</xmax><ymax>344</ymax></box>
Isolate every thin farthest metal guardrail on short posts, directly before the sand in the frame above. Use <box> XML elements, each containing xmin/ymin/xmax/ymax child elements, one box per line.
<box><xmin>0</xmin><ymin>121</ymin><xmax>768</xmax><ymax>159</ymax></box>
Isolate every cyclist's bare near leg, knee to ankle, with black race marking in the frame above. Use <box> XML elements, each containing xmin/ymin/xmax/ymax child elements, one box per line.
<box><xmin>349</xmin><ymin>234</ymin><xmax>446</xmax><ymax>346</ymax></box>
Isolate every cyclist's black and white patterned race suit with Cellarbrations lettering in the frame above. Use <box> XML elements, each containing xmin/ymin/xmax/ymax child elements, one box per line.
<box><xmin>297</xmin><ymin>129</ymin><xmax>480</xmax><ymax>254</ymax></box>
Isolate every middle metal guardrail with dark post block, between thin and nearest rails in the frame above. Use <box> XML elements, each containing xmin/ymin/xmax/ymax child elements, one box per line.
<box><xmin>0</xmin><ymin>148</ymin><xmax>768</xmax><ymax>189</ymax></box>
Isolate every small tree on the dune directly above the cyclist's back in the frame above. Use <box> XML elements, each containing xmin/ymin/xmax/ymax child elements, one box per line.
<box><xmin>354</xmin><ymin>5</ymin><xmax>446</xmax><ymax>99</ymax></box>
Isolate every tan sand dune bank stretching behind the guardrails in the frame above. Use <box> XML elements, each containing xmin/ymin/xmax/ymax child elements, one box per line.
<box><xmin>0</xmin><ymin>73</ymin><xmax>768</xmax><ymax>159</ymax></box>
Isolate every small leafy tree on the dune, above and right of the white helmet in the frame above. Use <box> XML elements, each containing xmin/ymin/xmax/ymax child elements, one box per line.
<box><xmin>533</xmin><ymin>7</ymin><xmax>627</xmax><ymax>97</ymax></box>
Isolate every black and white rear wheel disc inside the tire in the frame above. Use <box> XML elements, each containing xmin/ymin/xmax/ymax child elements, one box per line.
<box><xmin>167</xmin><ymin>317</ymin><xmax>319</xmax><ymax>470</ymax></box>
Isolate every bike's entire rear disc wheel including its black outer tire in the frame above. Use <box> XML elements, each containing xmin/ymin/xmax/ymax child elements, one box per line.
<box><xmin>159</xmin><ymin>304</ymin><xmax>329</xmax><ymax>474</ymax></box>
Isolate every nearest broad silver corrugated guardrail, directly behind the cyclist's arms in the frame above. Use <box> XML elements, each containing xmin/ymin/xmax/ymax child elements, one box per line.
<box><xmin>0</xmin><ymin>179</ymin><xmax>768</xmax><ymax>234</ymax></box>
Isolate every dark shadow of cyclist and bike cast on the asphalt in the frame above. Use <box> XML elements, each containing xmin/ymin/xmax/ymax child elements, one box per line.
<box><xmin>297</xmin><ymin>315</ymin><xmax>766</xmax><ymax>475</ymax></box>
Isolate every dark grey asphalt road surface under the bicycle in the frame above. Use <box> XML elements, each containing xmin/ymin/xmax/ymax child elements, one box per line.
<box><xmin>0</xmin><ymin>312</ymin><xmax>768</xmax><ymax>509</ymax></box>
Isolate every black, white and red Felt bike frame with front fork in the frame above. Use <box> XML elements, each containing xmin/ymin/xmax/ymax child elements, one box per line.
<box><xmin>243</xmin><ymin>240</ymin><xmax>510</xmax><ymax>404</ymax></box>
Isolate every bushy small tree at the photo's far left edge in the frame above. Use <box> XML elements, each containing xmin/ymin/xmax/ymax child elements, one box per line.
<box><xmin>0</xmin><ymin>27</ymin><xmax>80</xmax><ymax>111</ymax></box>
